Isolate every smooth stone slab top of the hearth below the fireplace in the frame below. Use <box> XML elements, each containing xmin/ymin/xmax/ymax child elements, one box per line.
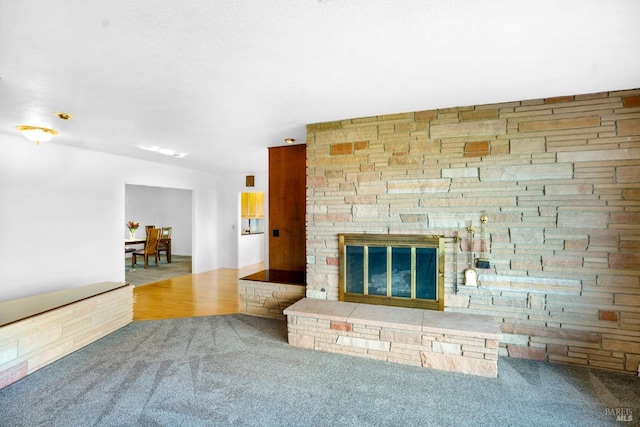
<box><xmin>284</xmin><ymin>298</ymin><xmax>502</xmax><ymax>340</ymax></box>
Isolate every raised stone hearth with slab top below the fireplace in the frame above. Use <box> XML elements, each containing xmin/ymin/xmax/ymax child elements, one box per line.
<box><xmin>284</xmin><ymin>298</ymin><xmax>502</xmax><ymax>378</ymax></box>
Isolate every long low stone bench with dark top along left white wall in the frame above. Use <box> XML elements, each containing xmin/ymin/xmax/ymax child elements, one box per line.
<box><xmin>0</xmin><ymin>282</ymin><xmax>134</xmax><ymax>389</ymax></box>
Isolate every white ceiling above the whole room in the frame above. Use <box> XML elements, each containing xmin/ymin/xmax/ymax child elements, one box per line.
<box><xmin>0</xmin><ymin>0</ymin><xmax>640</xmax><ymax>173</ymax></box>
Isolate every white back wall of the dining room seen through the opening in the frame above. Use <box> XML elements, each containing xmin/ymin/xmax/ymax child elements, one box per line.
<box><xmin>122</xmin><ymin>184</ymin><xmax>193</xmax><ymax>255</ymax></box>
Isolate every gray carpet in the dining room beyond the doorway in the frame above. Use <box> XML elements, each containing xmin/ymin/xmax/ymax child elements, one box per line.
<box><xmin>124</xmin><ymin>253</ymin><xmax>191</xmax><ymax>286</ymax></box>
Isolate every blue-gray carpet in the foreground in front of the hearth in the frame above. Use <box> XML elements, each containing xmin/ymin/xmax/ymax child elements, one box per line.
<box><xmin>0</xmin><ymin>314</ymin><xmax>640</xmax><ymax>427</ymax></box>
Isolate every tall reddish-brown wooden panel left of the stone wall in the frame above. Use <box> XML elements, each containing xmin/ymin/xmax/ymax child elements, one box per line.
<box><xmin>269</xmin><ymin>144</ymin><xmax>306</xmax><ymax>271</ymax></box>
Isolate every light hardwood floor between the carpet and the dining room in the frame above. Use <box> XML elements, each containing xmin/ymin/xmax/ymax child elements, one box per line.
<box><xmin>133</xmin><ymin>263</ymin><xmax>264</xmax><ymax>321</ymax></box>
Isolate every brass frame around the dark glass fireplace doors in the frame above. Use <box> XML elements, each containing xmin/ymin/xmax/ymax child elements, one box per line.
<box><xmin>338</xmin><ymin>233</ymin><xmax>445</xmax><ymax>311</ymax></box>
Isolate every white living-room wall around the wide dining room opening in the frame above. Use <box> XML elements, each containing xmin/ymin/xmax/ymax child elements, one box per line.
<box><xmin>0</xmin><ymin>134</ymin><xmax>222</xmax><ymax>301</ymax></box>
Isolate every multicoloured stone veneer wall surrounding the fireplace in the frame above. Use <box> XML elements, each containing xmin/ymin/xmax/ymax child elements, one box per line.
<box><xmin>307</xmin><ymin>89</ymin><xmax>640</xmax><ymax>373</ymax></box>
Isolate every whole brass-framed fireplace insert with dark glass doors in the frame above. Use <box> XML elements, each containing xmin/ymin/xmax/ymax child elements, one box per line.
<box><xmin>338</xmin><ymin>234</ymin><xmax>444</xmax><ymax>310</ymax></box>
